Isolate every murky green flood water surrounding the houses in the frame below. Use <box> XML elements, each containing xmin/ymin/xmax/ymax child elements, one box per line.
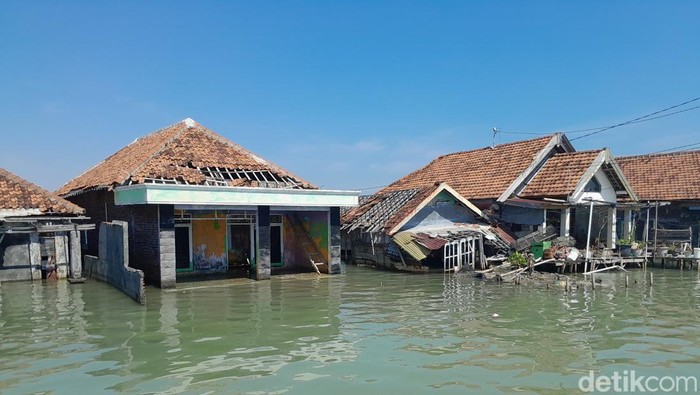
<box><xmin>0</xmin><ymin>267</ymin><xmax>700</xmax><ymax>395</ymax></box>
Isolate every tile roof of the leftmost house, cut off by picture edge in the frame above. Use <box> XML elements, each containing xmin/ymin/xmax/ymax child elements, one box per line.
<box><xmin>0</xmin><ymin>168</ymin><xmax>85</xmax><ymax>215</ymax></box>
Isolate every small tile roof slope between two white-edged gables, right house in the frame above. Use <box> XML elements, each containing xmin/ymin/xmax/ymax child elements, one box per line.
<box><xmin>518</xmin><ymin>150</ymin><xmax>603</xmax><ymax>197</ymax></box>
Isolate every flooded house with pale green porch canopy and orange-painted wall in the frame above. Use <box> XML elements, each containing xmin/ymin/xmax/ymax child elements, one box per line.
<box><xmin>58</xmin><ymin>118</ymin><xmax>358</xmax><ymax>288</ymax></box>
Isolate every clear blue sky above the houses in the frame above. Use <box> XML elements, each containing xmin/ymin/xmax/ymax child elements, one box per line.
<box><xmin>0</xmin><ymin>0</ymin><xmax>700</xmax><ymax>192</ymax></box>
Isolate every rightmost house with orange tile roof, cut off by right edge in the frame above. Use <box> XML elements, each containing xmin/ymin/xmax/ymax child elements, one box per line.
<box><xmin>617</xmin><ymin>150</ymin><xmax>700</xmax><ymax>247</ymax></box>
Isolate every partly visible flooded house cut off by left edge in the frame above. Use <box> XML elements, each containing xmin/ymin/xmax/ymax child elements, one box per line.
<box><xmin>0</xmin><ymin>168</ymin><xmax>94</xmax><ymax>281</ymax></box>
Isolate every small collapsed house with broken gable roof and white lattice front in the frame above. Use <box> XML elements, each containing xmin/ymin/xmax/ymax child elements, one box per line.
<box><xmin>341</xmin><ymin>183</ymin><xmax>509</xmax><ymax>272</ymax></box>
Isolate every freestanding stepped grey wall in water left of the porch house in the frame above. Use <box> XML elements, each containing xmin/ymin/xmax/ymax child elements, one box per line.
<box><xmin>83</xmin><ymin>221</ymin><xmax>146</xmax><ymax>304</ymax></box>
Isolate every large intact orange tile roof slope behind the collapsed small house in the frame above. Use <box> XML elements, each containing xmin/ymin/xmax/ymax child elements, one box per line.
<box><xmin>380</xmin><ymin>135</ymin><xmax>556</xmax><ymax>200</ymax></box>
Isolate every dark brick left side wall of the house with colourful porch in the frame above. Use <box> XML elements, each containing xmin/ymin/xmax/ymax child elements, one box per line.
<box><xmin>67</xmin><ymin>190</ymin><xmax>160</xmax><ymax>285</ymax></box>
